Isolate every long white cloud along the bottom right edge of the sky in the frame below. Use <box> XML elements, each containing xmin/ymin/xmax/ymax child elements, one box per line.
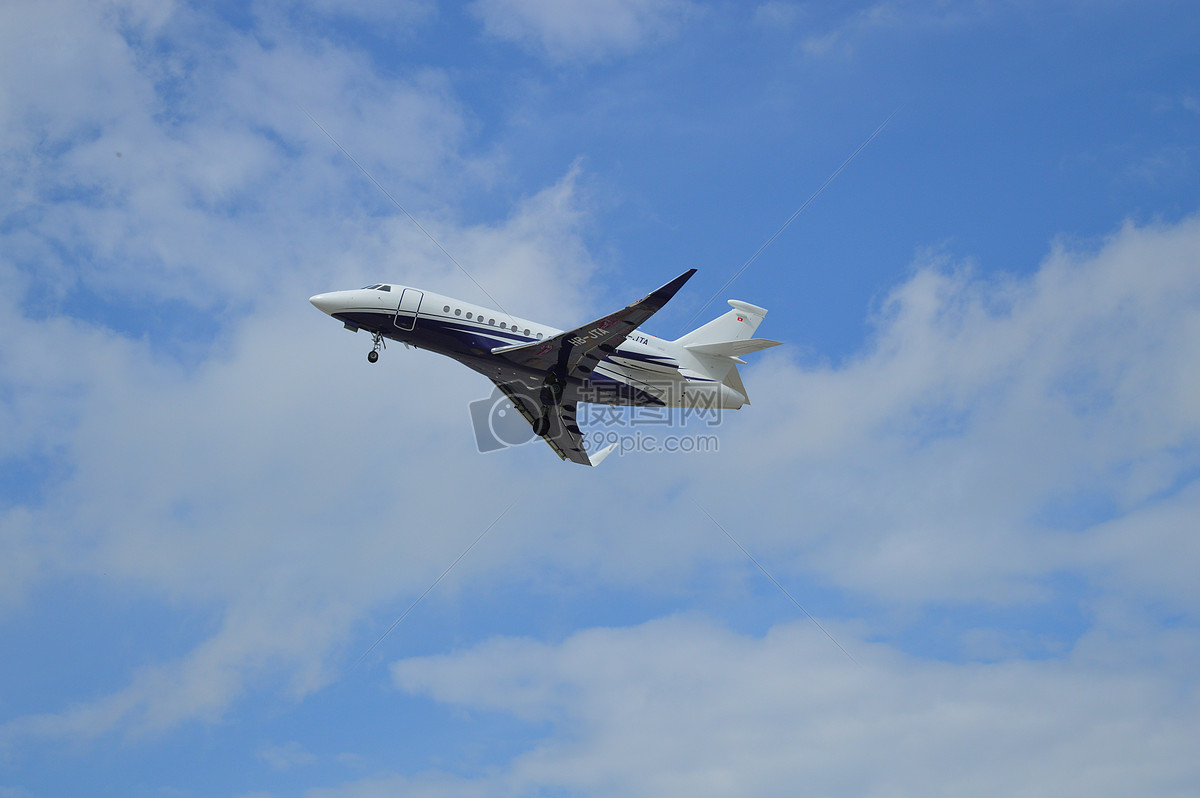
<box><xmin>386</xmin><ymin>617</ymin><xmax>1200</xmax><ymax>796</ymax></box>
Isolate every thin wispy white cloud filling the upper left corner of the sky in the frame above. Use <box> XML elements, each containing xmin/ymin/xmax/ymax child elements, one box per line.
<box><xmin>0</xmin><ymin>4</ymin><xmax>491</xmax><ymax>311</ymax></box>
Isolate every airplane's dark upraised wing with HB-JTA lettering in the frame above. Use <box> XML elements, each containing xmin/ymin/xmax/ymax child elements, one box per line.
<box><xmin>492</xmin><ymin>269</ymin><xmax>696</xmax><ymax>382</ymax></box>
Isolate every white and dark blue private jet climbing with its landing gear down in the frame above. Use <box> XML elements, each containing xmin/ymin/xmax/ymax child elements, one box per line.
<box><xmin>308</xmin><ymin>269</ymin><xmax>781</xmax><ymax>466</ymax></box>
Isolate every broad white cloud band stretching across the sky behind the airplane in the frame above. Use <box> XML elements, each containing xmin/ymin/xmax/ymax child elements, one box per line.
<box><xmin>9</xmin><ymin>189</ymin><xmax>1200</xmax><ymax>737</ymax></box>
